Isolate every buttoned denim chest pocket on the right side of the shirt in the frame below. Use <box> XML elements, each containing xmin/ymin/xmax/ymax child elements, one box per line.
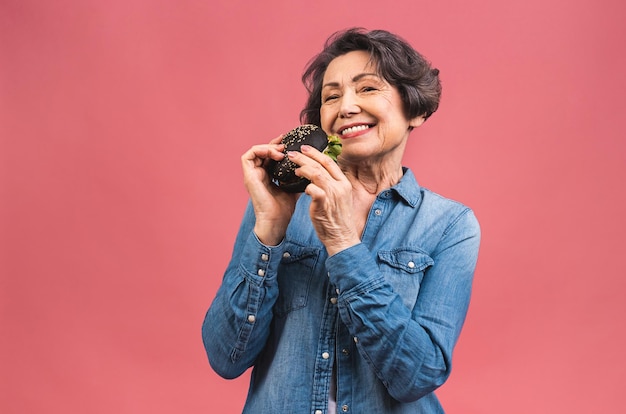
<box><xmin>378</xmin><ymin>248</ymin><xmax>435</xmax><ymax>309</ymax></box>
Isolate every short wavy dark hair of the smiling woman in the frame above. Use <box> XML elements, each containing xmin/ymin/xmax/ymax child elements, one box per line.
<box><xmin>300</xmin><ymin>28</ymin><xmax>441</xmax><ymax>126</ymax></box>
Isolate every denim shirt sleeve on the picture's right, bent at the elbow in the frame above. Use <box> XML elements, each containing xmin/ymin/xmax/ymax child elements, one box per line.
<box><xmin>326</xmin><ymin>210</ymin><xmax>480</xmax><ymax>402</ymax></box>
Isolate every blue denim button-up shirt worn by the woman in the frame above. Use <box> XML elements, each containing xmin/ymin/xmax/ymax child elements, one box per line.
<box><xmin>202</xmin><ymin>168</ymin><xmax>480</xmax><ymax>414</ymax></box>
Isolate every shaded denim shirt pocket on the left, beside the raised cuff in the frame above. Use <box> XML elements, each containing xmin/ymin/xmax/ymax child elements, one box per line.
<box><xmin>274</xmin><ymin>242</ymin><xmax>320</xmax><ymax>317</ymax></box>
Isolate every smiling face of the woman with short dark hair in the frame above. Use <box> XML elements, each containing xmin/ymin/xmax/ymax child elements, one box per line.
<box><xmin>320</xmin><ymin>51</ymin><xmax>423</xmax><ymax>167</ymax></box>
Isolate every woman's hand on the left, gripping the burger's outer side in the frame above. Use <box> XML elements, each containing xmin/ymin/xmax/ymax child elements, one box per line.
<box><xmin>241</xmin><ymin>135</ymin><xmax>298</xmax><ymax>246</ymax></box>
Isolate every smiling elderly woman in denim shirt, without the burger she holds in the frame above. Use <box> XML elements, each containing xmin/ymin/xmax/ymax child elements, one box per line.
<box><xmin>203</xmin><ymin>29</ymin><xmax>480</xmax><ymax>414</ymax></box>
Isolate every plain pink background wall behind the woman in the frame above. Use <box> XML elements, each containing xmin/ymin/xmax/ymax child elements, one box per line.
<box><xmin>0</xmin><ymin>0</ymin><xmax>626</xmax><ymax>414</ymax></box>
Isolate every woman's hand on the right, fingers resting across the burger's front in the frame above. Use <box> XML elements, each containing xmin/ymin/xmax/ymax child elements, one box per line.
<box><xmin>287</xmin><ymin>145</ymin><xmax>361</xmax><ymax>256</ymax></box>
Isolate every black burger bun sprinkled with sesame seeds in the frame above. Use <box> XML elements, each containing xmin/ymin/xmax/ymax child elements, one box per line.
<box><xmin>265</xmin><ymin>124</ymin><xmax>328</xmax><ymax>193</ymax></box>
